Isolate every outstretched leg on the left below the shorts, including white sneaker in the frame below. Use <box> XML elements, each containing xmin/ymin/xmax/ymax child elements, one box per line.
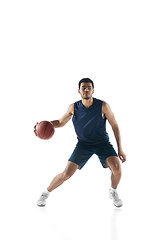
<box><xmin>37</xmin><ymin>161</ymin><xmax>79</xmax><ymax>207</ymax></box>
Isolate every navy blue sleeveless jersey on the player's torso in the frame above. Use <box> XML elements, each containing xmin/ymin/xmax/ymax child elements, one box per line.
<box><xmin>72</xmin><ymin>98</ymin><xmax>109</xmax><ymax>144</ymax></box>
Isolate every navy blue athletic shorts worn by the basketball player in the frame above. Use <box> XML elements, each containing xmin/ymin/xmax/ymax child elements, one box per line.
<box><xmin>68</xmin><ymin>141</ymin><xmax>118</xmax><ymax>169</ymax></box>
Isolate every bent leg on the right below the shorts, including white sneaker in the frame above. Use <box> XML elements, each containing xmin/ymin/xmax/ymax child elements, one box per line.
<box><xmin>105</xmin><ymin>156</ymin><xmax>123</xmax><ymax>207</ymax></box>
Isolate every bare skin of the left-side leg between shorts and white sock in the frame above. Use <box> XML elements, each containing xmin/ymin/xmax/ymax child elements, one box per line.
<box><xmin>47</xmin><ymin>162</ymin><xmax>79</xmax><ymax>192</ymax></box>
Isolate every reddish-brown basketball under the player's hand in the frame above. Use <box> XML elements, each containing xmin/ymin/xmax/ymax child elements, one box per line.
<box><xmin>35</xmin><ymin>121</ymin><xmax>55</xmax><ymax>140</ymax></box>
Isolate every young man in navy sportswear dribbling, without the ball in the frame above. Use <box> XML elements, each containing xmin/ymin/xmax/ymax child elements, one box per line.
<box><xmin>34</xmin><ymin>78</ymin><xmax>126</xmax><ymax>207</ymax></box>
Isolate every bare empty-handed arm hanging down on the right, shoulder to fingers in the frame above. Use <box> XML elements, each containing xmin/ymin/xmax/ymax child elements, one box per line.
<box><xmin>102</xmin><ymin>102</ymin><xmax>126</xmax><ymax>163</ymax></box>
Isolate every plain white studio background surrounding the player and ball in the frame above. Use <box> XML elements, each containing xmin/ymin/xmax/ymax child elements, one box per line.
<box><xmin>0</xmin><ymin>0</ymin><xmax>160</xmax><ymax>240</ymax></box>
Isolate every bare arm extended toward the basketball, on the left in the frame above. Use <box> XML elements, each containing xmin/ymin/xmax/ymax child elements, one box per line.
<box><xmin>51</xmin><ymin>103</ymin><xmax>74</xmax><ymax>128</ymax></box>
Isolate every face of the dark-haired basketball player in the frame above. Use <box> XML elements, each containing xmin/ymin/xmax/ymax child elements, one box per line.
<box><xmin>78</xmin><ymin>82</ymin><xmax>94</xmax><ymax>100</ymax></box>
